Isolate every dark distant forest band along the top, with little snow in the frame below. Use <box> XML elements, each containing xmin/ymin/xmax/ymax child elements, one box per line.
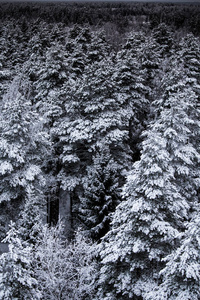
<box><xmin>0</xmin><ymin>2</ymin><xmax>200</xmax><ymax>35</ymax></box>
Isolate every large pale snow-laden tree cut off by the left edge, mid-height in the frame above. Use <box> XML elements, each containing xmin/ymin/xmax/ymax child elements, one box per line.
<box><xmin>0</xmin><ymin>78</ymin><xmax>49</xmax><ymax>239</ymax></box>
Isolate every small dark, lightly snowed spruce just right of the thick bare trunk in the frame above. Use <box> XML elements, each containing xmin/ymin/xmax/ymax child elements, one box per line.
<box><xmin>79</xmin><ymin>145</ymin><xmax>121</xmax><ymax>241</ymax></box>
